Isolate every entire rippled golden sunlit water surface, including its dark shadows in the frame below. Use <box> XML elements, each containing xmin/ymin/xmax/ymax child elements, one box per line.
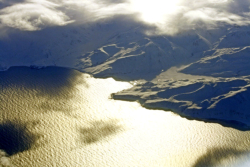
<box><xmin>0</xmin><ymin>67</ymin><xmax>250</xmax><ymax>167</ymax></box>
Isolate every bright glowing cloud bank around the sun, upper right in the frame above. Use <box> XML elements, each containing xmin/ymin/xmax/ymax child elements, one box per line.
<box><xmin>131</xmin><ymin>0</ymin><xmax>250</xmax><ymax>35</ymax></box>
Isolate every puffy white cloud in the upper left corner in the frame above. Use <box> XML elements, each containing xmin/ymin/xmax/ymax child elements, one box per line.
<box><xmin>0</xmin><ymin>0</ymin><xmax>71</xmax><ymax>31</ymax></box>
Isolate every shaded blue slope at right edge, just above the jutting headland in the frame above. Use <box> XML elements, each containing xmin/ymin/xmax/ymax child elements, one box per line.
<box><xmin>181</xmin><ymin>46</ymin><xmax>250</xmax><ymax>77</ymax></box>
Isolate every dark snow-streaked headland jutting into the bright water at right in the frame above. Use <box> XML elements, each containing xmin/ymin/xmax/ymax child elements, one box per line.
<box><xmin>113</xmin><ymin>68</ymin><xmax>250</xmax><ymax>129</ymax></box>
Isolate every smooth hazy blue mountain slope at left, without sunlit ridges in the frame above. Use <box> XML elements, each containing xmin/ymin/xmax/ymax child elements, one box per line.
<box><xmin>0</xmin><ymin>18</ymin><xmax>141</xmax><ymax>69</ymax></box>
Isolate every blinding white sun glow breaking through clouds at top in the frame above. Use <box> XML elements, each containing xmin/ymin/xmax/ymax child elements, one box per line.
<box><xmin>131</xmin><ymin>0</ymin><xmax>181</xmax><ymax>24</ymax></box>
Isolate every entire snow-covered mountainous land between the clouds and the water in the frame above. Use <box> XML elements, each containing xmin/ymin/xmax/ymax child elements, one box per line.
<box><xmin>0</xmin><ymin>18</ymin><xmax>250</xmax><ymax>128</ymax></box>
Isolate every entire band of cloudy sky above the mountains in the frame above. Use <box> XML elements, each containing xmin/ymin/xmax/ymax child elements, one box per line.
<box><xmin>0</xmin><ymin>0</ymin><xmax>250</xmax><ymax>34</ymax></box>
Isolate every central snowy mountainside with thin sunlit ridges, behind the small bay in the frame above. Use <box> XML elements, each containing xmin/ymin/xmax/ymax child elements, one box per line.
<box><xmin>75</xmin><ymin>26</ymin><xmax>225</xmax><ymax>80</ymax></box>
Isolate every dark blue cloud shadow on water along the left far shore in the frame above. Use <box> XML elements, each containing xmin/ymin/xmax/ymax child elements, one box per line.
<box><xmin>0</xmin><ymin>66</ymin><xmax>87</xmax><ymax>98</ymax></box>
